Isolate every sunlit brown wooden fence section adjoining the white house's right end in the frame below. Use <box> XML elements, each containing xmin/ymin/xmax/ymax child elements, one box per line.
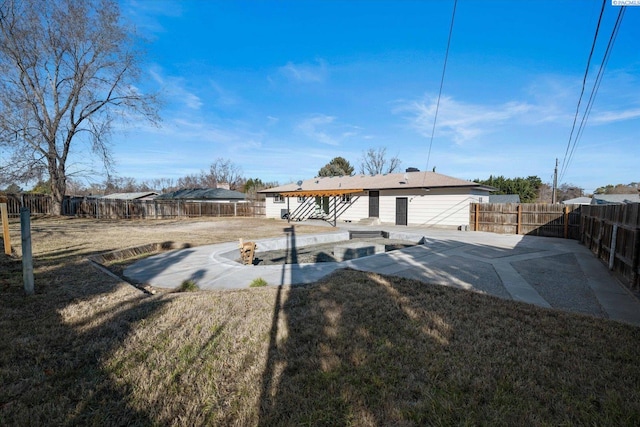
<box><xmin>469</xmin><ymin>203</ymin><xmax>581</xmax><ymax>240</ymax></box>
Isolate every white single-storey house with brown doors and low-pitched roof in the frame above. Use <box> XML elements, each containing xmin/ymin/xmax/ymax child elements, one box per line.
<box><xmin>260</xmin><ymin>169</ymin><xmax>496</xmax><ymax>228</ymax></box>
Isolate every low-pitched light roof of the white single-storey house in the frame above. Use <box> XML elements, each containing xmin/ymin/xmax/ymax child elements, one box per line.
<box><xmin>260</xmin><ymin>172</ymin><xmax>495</xmax><ymax>196</ymax></box>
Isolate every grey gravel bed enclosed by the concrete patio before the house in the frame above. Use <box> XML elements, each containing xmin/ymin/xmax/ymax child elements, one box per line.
<box><xmin>244</xmin><ymin>237</ymin><xmax>416</xmax><ymax>265</ymax></box>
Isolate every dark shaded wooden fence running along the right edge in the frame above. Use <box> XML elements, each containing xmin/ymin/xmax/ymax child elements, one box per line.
<box><xmin>581</xmin><ymin>203</ymin><xmax>640</xmax><ymax>291</ymax></box>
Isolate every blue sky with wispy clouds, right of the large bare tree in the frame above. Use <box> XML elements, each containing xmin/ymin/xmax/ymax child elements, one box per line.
<box><xmin>107</xmin><ymin>0</ymin><xmax>640</xmax><ymax>192</ymax></box>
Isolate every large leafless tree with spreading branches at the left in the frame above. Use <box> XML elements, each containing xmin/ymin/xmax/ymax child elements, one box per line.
<box><xmin>0</xmin><ymin>0</ymin><xmax>158</xmax><ymax>214</ymax></box>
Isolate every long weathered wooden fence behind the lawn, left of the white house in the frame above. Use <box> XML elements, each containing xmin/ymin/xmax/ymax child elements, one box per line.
<box><xmin>62</xmin><ymin>197</ymin><xmax>265</xmax><ymax>219</ymax></box>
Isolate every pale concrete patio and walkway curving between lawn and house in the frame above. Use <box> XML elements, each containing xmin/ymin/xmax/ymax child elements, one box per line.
<box><xmin>124</xmin><ymin>224</ymin><xmax>640</xmax><ymax>326</ymax></box>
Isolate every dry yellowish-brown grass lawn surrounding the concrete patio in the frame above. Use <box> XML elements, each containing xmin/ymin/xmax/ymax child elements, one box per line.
<box><xmin>0</xmin><ymin>219</ymin><xmax>640</xmax><ymax>426</ymax></box>
